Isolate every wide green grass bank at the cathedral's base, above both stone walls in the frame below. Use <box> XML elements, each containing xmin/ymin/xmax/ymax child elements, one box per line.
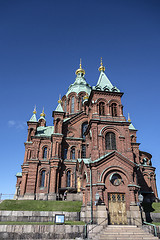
<box><xmin>0</xmin><ymin>200</ymin><xmax>82</xmax><ymax>212</ymax></box>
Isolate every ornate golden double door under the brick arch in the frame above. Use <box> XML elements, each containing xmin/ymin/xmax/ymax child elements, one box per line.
<box><xmin>108</xmin><ymin>193</ymin><xmax>127</xmax><ymax>224</ymax></box>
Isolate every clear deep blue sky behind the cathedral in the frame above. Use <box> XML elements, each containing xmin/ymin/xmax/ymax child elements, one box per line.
<box><xmin>0</xmin><ymin>0</ymin><xmax>160</xmax><ymax>197</ymax></box>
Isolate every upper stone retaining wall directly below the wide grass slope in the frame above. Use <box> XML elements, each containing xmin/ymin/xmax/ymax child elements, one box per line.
<box><xmin>0</xmin><ymin>211</ymin><xmax>80</xmax><ymax>222</ymax></box>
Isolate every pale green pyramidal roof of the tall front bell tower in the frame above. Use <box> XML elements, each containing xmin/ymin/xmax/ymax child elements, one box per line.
<box><xmin>93</xmin><ymin>71</ymin><xmax>120</xmax><ymax>92</ymax></box>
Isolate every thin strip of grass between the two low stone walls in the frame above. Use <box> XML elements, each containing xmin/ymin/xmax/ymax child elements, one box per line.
<box><xmin>0</xmin><ymin>221</ymin><xmax>85</xmax><ymax>225</ymax></box>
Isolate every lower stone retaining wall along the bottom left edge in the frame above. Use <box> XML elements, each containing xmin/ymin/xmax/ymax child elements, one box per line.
<box><xmin>0</xmin><ymin>225</ymin><xmax>85</xmax><ymax>240</ymax></box>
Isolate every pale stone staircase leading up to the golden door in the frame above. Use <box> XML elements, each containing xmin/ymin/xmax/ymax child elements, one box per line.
<box><xmin>89</xmin><ymin>225</ymin><xmax>159</xmax><ymax>240</ymax></box>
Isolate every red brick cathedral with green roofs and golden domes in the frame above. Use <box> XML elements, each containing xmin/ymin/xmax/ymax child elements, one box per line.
<box><xmin>16</xmin><ymin>60</ymin><xmax>158</xmax><ymax>224</ymax></box>
